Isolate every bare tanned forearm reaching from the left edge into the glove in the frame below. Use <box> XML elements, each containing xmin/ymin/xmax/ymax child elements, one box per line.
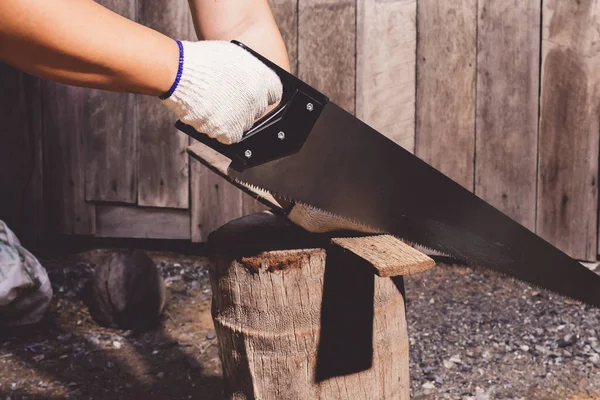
<box><xmin>0</xmin><ymin>0</ymin><xmax>179</xmax><ymax>96</ymax></box>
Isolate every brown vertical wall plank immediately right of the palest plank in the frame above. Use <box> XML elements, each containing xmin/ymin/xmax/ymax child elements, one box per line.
<box><xmin>416</xmin><ymin>0</ymin><xmax>477</xmax><ymax>190</ymax></box>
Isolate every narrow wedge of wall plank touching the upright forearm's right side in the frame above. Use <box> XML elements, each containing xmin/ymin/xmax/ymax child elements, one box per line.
<box><xmin>269</xmin><ymin>0</ymin><xmax>298</xmax><ymax>75</ymax></box>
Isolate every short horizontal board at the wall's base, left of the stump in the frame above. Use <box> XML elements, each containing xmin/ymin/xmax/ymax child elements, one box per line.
<box><xmin>96</xmin><ymin>204</ymin><xmax>190</xmax><ymax>240</ymax></box>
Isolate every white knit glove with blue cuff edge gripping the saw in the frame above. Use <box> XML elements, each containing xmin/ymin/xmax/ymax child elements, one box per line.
<box><xmin>161</xmin><ymin>40</ymin><xmax>282</xmax><ymax>144</ymax></box>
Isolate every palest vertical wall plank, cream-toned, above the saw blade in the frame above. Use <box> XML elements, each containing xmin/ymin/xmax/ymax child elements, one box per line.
<box><xmin>356</xmin><ymin>0</ymin><xmax>417</xmax><ymax>152</ymax></box>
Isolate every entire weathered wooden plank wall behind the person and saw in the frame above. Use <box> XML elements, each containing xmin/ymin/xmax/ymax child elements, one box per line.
<box><xmin>0</xmin><ymin>0</ymin><xmax>600</xmax><ymax>260</ymax></box>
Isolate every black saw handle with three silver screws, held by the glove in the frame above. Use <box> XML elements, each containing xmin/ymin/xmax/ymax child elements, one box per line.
<box><xmin>175</xmin><ymin>40</ymin><xmax>329</xmax><ymax>170</ymax></box>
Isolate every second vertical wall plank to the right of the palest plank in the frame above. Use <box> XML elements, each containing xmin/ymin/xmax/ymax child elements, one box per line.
<box><xmin>475</xmin><ymin>0</ymin><xmax>541</xmax><ymax>230</ymax></box>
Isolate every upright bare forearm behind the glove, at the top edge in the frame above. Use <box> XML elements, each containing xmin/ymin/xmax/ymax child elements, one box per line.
<box><xmin>189</xmin><ymin>0</ymin><xmax>290</xmax><ymax>71</ymax></box>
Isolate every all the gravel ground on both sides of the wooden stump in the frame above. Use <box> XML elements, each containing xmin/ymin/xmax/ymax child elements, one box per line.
<box><xmin>0</xmin><ymin>252</ymin><xmax>600</xmax><ymax>400</ymax></box>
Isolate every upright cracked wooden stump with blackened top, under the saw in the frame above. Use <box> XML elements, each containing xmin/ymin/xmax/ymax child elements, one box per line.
<box><xmin>209</xmin><ymin>213</ymin><xmax>433</xmax><ymax>400</ymax></box>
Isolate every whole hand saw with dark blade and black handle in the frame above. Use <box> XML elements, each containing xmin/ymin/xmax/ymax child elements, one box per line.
<box><xmin>176</xmin><ymin>41</ymin><xmax>600</xmax><ymax>307</ymax></box>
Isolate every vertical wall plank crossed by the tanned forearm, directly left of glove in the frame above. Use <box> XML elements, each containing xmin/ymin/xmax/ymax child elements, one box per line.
<box><xmin>137</xmin><ymin>0</ymin><xmax>196</xmax><ymax>208</ymax></box>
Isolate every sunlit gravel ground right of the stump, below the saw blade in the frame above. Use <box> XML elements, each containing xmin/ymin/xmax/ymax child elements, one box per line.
<box><xmin>406</xmin><ymin>265</ymin><xmax>600</xmax><ymax>400</ymax></box>
